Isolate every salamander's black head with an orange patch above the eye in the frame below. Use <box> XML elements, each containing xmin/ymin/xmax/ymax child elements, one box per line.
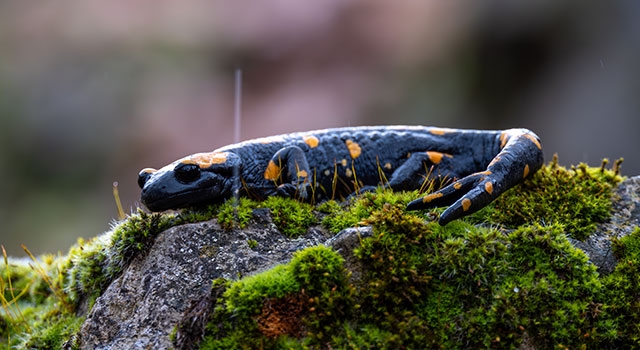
<box><xmin>138</xmin><ymin>152</ymin><xmax>240</xmax><ymax>211</ymax></box>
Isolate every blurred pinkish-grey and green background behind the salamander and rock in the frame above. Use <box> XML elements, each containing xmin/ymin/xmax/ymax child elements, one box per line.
<box><xmin>0</xmin><ymin>0</ymin><xmax>640</xmax><ymax>256</ymax></box>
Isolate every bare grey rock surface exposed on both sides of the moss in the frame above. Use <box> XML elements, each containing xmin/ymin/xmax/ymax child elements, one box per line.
<box><xmin>72</xmin><ymin>176</ymin><xmax>640</xmax><ymax>349</ymax></box>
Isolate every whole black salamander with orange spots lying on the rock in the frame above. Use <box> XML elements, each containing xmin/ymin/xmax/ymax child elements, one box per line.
<box><xmin>138</xmin><ymin>126</ymin><xmax>543</xmax><ymax>225</ymax></box>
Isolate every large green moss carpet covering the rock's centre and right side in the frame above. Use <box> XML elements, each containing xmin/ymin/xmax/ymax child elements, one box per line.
<box><xmin>194</xmin><ymin>159</ymin><xmax>624</xmax><ymax>348</ymax></box>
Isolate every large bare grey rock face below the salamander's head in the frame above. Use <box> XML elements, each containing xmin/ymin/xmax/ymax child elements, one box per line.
<box><xmin>78</xmin><ymin>209</ymin><xmax>329</xmax><ymax>349</ymax></box>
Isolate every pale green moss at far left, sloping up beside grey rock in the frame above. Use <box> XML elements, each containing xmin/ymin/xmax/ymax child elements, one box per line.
<box><xmin>0</xmin><ymin>211</ymin><xmax>179</xmax><ymax>349</ymax></box>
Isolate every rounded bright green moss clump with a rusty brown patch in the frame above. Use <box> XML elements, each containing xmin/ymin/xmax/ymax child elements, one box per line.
<box><xmin>201</xmin><ymin>246</ymin><xmax>352</xmax><ymax>349</ymax></box>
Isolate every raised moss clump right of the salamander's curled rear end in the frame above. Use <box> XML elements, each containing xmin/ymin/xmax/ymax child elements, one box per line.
<box><xmin>473</xmin><ymin>157</ymin><xmax>622</xmax><ymax>240</ymax></box>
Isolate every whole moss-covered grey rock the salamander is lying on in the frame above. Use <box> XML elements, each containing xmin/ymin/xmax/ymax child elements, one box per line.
<box><xmin>5</xmin><ymin>161</ymin><xmax>640</xmax><ymax>348</ymax></box>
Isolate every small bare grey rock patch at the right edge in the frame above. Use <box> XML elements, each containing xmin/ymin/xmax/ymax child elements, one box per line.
<box><xmin>569</xmin><ymin>176</ymin><xmax>640</xmax><ymax>273</ymax></box>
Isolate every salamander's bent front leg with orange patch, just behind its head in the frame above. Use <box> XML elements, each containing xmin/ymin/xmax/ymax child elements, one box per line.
<box><xmin>264</xmin><ymin>146</ymin><xmax>312</xmax><ymax>200</ymax></box>
